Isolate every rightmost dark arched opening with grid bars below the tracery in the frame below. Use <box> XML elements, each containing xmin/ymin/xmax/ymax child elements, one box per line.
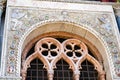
<box><xmin>80</xmin><ymin>60</ymin><xmax>98</xmax><ymax>80</ymax></box>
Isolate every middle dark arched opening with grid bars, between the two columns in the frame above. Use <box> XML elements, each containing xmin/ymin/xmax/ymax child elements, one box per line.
<box><xmin>53</xmin><ymin>59</ymin><xmax>73</xmax><ymax>80</ymax></box>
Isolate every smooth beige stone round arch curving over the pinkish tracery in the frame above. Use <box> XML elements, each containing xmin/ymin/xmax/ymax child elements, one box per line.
<box><xmin>18</xmin><ymin>21</ymin><xmax>114</xmax><ymax>80</ymax></box>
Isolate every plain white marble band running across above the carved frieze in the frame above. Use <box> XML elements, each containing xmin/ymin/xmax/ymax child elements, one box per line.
<box><xmin>7</xmin><ymin>0</ymin><xmax>113</xmax><ymax>12</ymax></box>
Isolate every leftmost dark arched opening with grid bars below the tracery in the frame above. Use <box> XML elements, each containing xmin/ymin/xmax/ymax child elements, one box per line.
<box><xmin>26</xmin><ymin>58</ymin><xmax>48</xmax><ymax>80</ymax></box>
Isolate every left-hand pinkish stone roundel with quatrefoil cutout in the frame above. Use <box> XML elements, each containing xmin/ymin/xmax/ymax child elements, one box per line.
<box><xmin>35</xmin><ymin>37</ymin><xmax>61</xmax><ymax>58</ymax></box>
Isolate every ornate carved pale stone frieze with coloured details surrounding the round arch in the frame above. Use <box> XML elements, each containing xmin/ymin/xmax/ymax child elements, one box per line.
<box><xmin>6</xmin><ymin>7</ymin><xmax>120</xmax><ymax>78</ymax></box>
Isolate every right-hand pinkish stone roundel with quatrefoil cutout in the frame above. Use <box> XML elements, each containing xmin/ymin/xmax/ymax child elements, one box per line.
<box><xmin>63</xmin><ymin>39</ymin><xmax>87</xmax><ymax>62</ymax></box>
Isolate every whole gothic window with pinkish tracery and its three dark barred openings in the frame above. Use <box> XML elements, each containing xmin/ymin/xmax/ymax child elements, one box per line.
<box><xmin>21</xmin><ymin>37</ymin><xmax>105</xmax><ymax>80</ymax></box>
